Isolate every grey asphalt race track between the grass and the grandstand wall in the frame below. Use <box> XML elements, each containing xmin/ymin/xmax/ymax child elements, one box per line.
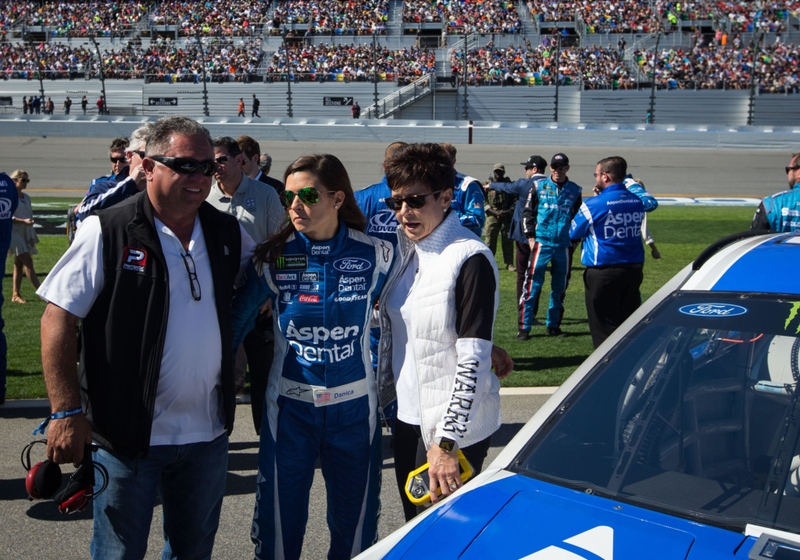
<box><xmin>0</xmin><ymin>132</ymin><xmax>800</xmax><ymax>198</ymax></box>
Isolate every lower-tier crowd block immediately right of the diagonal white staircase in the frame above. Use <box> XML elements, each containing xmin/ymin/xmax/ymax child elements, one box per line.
<box><xmin>450</xmin><ymin>44</ymin><xmax>636</xmax><ymax>89</ymax></box>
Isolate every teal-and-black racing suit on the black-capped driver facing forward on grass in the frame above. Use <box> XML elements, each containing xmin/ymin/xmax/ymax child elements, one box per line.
<box><xmin>519</xmin><ymin>178</ymin><xmax>582</xmax><ymax>331</ymax></box>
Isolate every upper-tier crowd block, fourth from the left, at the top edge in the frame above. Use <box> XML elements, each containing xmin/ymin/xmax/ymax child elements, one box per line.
<box><xmin>403</xmin><ymin>0</ymin><xmax>522</xmax><ymax>34</ymax></box>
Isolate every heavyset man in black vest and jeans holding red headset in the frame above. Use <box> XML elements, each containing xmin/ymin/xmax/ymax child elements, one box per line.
<box><xmin>38</xmin><ymin>117</ymin><xmax>253</xmax><ymax>560</ymax></box>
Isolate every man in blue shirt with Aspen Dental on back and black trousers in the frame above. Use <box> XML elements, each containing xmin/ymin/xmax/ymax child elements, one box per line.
<box><xmin>569</xmin><ymin>156</ymin><xmax>644</xmax><ymax>348</ymax></box>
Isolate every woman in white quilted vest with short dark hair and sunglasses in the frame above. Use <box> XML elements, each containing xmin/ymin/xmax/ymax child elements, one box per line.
<box><xmin>378</xmin><ymin>144</ymin><xmax>501</xmax><ymax>520</ymax></box>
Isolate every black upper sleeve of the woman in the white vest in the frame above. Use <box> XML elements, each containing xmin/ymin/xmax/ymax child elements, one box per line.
<box><xmin>456</xmin><ymin>253</ymin><xmax>497</xmax><ymax>340</ymax></box>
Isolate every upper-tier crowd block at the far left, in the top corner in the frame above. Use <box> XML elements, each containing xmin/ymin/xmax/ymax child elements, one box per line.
<box><xmin>7</xmin><ymin>0</ymin><xmax>151</xmax><ymax>37</ymax></box>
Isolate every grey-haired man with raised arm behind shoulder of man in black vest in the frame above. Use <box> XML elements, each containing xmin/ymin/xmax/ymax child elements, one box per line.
<box><xmin>75</xmin><ymin>122</ymin><xmax>153</xmax><ymax>227</ymax></box>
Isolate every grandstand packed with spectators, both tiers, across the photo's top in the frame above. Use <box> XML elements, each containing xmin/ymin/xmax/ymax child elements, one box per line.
<box><xmin>0</xmin><ymin>0</ymin><xmax>800</xmax><ymax>93</ymax></box>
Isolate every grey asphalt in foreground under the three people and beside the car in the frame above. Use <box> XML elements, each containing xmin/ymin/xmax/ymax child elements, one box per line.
<box><xmin>0</xmin><ymin>394</ymin><xmax>547</xmax><ymax>560</ymax></box>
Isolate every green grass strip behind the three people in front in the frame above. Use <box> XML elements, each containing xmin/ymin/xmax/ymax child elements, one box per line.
<box><xmin>3</xmin><ymin>203</ymin><xmax>753</xmax><ymax>399</ymax></box>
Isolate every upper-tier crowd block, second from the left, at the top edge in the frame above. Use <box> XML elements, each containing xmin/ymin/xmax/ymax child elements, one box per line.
<box><xmin>150</xmin><ymin>0</ymin><xmax>269</xmax><ymax>36</ymax></box>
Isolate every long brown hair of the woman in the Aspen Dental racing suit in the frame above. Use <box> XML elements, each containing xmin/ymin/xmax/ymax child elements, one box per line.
<box><xmin>255</xmin><ymin>154</ymin><xmax>366</xmax><ymax>263</ymax></box>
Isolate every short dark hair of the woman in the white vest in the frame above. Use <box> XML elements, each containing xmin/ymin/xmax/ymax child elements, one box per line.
<box><xmin>384</xmin><ymin>144</ymin><xmax>456</xmax><ymax>193</ymax></box>
